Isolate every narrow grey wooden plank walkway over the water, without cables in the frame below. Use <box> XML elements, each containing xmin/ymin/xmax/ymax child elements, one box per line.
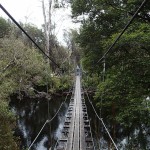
<box><xmin>55</xmin><ymin>67</ymin><xmax>94</xmax><ymax>150</ymax></box>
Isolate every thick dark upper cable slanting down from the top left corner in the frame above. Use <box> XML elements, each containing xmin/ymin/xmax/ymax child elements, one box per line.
<box><xmin>0</xmin><ymin>4</ymin><xmax>60</xmax><ymax>68</ymax></box>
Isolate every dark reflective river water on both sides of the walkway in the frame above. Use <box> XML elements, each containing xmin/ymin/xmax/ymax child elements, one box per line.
<box><xmin>10</xmin><ymin>93</ymin><xmax>150</xmax><ymax>150</ymax></box>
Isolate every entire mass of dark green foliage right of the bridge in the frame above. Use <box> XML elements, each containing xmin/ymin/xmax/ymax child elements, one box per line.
<box><xmin>72</xmin><ymin>0</ymin><xmax>150</xmax><ymax>149</ymax></box>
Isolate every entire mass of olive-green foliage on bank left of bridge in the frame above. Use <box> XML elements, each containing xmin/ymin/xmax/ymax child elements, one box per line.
<box><xmin>0</xmin><ymin>18</ymin><xmax>72</xmax><ymax>150</ymax></box>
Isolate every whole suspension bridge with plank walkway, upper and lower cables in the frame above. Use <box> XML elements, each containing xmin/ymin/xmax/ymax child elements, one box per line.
<box><xmin>0</xmin><ymin>0</ymin><xmax>148</xmax><ymax>150</ymax></box>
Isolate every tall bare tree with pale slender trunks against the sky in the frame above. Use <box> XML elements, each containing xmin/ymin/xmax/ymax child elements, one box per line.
<box><xmin>42</xmin><ymin>0</ymin><xmax>71</xmax><ymax>72</ymax></box>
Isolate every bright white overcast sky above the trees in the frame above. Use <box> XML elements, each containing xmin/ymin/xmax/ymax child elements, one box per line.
<box><xmin>0</xmin><ymin>0</ymin><xmax>80</xmax><ymax>45</ymax></box>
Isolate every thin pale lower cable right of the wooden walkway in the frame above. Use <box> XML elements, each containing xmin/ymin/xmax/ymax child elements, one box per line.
<box><xmin>85</xmin><ymin>90</ymin><xmax>118</xmax><ymax>150</ymax></box>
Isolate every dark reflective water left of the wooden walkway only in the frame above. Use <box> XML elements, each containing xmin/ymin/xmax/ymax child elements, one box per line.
<box><xmin>10</xmin><ymin>96</ymin><xmax>68</xmax><ymax>150</ymax></box>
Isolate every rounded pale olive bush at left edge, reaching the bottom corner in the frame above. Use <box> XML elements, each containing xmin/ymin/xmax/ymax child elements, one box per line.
<box><xmin>0</xmin><ymin>37</ymin><xmax>48</xmax><ymax>150</ymax></box>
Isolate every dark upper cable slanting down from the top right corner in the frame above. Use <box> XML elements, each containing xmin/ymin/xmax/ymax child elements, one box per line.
<box><xmin>97</xmin><ymin>0</ymin><xmax>148</xmax><ymax>63</ymax></box>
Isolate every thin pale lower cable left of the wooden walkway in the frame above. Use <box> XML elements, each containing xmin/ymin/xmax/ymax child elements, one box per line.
<box><xmin>28</xmin><ymin>94</ymin><xmax>69</xmax><ymax>150</ymax></box>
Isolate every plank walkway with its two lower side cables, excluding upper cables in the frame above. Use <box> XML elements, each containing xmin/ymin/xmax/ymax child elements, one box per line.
<box><xmin>28</xmin><ymin>66</ymin><xmax>118</xmax><ymax>150</ymax></box>
